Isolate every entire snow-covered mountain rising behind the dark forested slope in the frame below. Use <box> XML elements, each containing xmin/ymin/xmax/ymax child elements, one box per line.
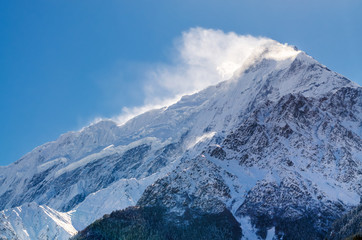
<box><xmin>0</xmin><ymin>42</ymin><xmax>362</xmax><ymax>239</ymax></box>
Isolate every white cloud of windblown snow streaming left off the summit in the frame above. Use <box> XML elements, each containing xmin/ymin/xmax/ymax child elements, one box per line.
<box><xmin>115</xmin><ymin>28</ymin><xmax>272</xmax><ymax>123</ymax></box>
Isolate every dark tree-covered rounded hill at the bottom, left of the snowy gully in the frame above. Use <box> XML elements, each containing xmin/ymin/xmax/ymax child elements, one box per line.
<box><xmin>71</xmin><ymin>206</ymin><xmax>241</xmax><ymax>240</ymax></box>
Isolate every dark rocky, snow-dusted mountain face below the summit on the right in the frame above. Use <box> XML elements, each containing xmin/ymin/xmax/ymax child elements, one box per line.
<box><xmin>138</xmin><ymin>88</ymin><xmax>362</xmax><ymax>239</ymax></box>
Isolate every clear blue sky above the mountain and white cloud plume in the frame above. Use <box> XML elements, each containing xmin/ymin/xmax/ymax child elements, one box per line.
<box><xmin>0</xmin><ymin>0</ymin><xmax>362</xmax><ymax>165</ymax></box>
